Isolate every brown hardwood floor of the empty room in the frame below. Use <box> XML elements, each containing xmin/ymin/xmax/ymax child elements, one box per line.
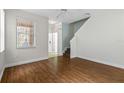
<box><xmin>1</xmin><ymin>56</ymin><xmax>124</xmax><ymax>83</ymax></box>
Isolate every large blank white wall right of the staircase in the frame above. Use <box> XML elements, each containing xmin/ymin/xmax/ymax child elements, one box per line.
<box><xmin>72</xmin><ymin>10</ymin><xmax>124</xmax><ymax>68</ymax></box>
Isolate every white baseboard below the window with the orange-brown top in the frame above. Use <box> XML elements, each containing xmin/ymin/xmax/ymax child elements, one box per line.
<box><xmin>5</xmin><ymin>57</ymin><xmax>48</xmax><ymax>67</ymax></box>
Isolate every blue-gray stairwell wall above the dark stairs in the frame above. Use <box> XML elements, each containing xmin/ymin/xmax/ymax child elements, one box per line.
<box><xmin>62</xmin><ymin>18</ymin><xmax>88</xmax><ymax>52</ymax></box>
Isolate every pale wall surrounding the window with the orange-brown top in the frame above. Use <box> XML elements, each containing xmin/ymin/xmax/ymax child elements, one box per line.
<box><xmin>5</xmin><ymin>10</ymin><xmax>48</xmax><ymax>66</ymax></box>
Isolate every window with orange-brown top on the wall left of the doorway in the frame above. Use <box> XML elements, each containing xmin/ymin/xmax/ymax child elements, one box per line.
<box><xmin>16</xmin><ymin>18</ymin><xmax>34</xmax><ymax>48</ymax></box>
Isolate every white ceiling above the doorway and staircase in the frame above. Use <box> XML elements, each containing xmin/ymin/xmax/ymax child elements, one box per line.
<box><xmin>23</xmin><ymin>9</ymin><xmax>90</xmax><ymax>23</ymax></box>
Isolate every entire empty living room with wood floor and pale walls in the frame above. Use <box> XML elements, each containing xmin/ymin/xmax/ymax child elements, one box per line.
<box><xmin>0</xmin><ymin>9</ymin><xmax>124</xmax><ymax>83</ymax></box>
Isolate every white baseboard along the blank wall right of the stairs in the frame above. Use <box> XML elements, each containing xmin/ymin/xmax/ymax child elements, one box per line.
<box><xmin>78</xmin><ymin>56</ymin><xmax>124</xmax><ymax>69</ymax></box>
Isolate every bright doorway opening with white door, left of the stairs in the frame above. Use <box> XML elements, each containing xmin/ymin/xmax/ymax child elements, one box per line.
<box><xmin>48</xmin><ymin>20</ymin><xmax>62</xmax><ymax>58</ymax></box>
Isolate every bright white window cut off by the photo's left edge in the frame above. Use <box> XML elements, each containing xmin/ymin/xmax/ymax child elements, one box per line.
<box><xmin>0</xmin><ymin>9</ymin><xmax>5</xmax><ymax>52</ymax></box>
